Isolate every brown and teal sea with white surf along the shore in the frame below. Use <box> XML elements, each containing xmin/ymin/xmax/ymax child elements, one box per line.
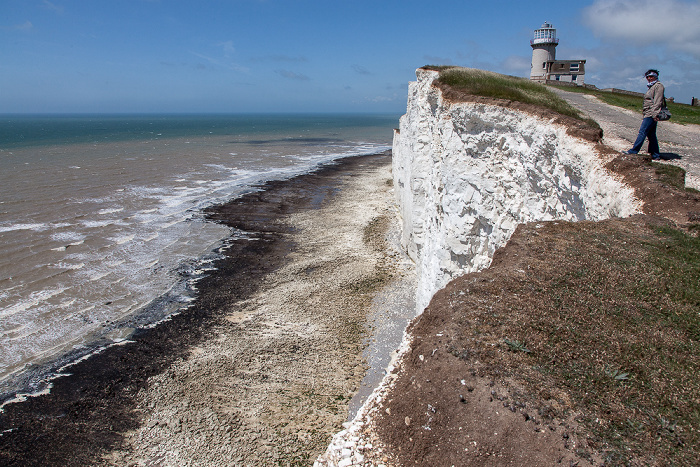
<box><xmin>0</xmin><ymin>114</ymin><xmax>399</xmax><ymax>402</ymax></box>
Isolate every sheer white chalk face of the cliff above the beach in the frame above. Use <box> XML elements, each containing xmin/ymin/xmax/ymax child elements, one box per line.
<box><xmin>393</xmin><ymin>69</ymin><xmax>641</xmax><ymax>311</ymax></box>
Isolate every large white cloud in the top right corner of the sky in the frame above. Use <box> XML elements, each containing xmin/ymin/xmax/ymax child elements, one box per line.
<box><xmin>583</xmin><ymin>0</ymin><xmax>700</xmax><ymax>58</ymax></box>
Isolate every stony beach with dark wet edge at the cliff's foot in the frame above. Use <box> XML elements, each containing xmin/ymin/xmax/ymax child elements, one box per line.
<box><xmin>0</xmin><ymin>153</ymin><xmax>412</xmax><ymax>466</ymax></box>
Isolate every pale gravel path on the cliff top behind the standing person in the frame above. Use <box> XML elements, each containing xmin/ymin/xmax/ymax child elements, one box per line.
<box><xmin>550</xmin><ymin>87</ymin><xmax>700</xmax><ymax>189</ymax></box>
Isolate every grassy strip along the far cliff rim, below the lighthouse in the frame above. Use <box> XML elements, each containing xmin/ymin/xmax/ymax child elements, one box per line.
<box><xmin>425</xmin><ymin>66</ymin><xmax>599</xmax><ymax>128</ymax></box>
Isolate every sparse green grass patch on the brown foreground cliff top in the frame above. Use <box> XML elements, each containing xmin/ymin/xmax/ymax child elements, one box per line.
<box><xmin>536</xmin><ymin>227</ymin><xmax>700</xmax><ymax>465</ymax></box>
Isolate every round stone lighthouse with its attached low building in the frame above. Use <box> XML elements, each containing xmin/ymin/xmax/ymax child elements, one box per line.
<box><xmin>530</xmin><ymin>21</ymin><xmax>586</xmax><ymax>86</ymax></box>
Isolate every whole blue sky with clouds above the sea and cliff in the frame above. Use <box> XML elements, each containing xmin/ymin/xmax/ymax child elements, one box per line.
<box><xmin>0</xmin><ymin>0</ymin><xmax>700</xmax><ymax>114</ymax></box>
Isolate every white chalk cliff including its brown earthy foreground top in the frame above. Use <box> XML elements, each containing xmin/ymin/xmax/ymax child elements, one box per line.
<box><xmin>317</xmin><ymin>69</ymin><xmax>700</xmax><ymax>466</ymax></box>
